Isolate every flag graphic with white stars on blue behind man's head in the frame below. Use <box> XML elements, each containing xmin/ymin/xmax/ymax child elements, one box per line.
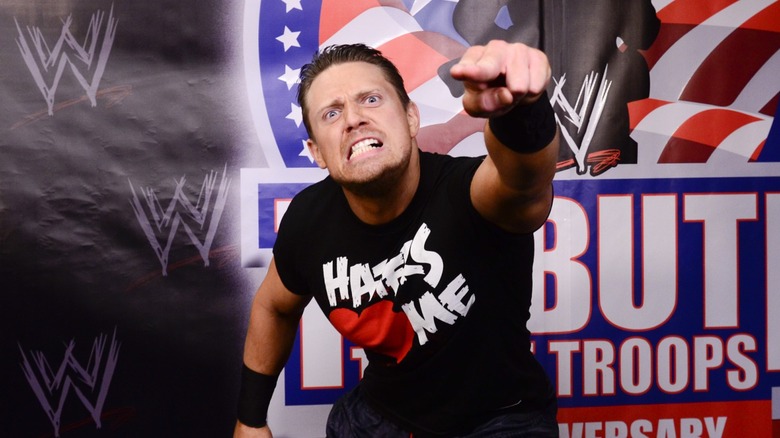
<box><xmin>260</xmin><ymin>0</ymin><xmax>474</xmax><ymax>167</ymax></box>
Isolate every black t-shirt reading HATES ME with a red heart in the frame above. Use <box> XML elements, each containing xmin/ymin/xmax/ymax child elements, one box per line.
<box><xmin>274</xmin><ymin>152</ymin><xmax>552</xmax><ymax>434</ymax></box>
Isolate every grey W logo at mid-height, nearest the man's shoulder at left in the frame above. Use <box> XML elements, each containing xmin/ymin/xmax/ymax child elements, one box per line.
<box><xmin>130</xmin><ymin>165</ymin><xmax>230</xmax><ymax>275</ymax></box>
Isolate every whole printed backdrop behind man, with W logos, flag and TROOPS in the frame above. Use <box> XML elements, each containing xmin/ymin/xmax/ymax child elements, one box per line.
<box><xmin>0</xmin><ymin>0</ymin><xmax>780</xmax><ymax>438</ymax></box>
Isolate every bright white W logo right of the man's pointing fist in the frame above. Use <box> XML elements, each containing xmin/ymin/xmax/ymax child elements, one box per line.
<box><xmin>550</xmin><ymin>65</ymin><xmax>612</xmax><ymax>175</ymax></box>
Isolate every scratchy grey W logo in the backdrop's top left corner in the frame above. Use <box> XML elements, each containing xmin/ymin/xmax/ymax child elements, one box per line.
<box><xmin>14</xmin><ymin>5</ymin><xmax>117</xmax><ymax>115</ymax></box>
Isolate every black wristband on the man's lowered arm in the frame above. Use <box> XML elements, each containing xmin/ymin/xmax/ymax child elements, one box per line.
<box><xmin>238</xmin><ymin>365</ymin><xmax>279</xmax><ymax>427</ymax></box>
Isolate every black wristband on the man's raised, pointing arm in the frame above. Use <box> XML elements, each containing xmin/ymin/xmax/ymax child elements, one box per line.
<box><xmin>488</xmin><ymin>91</ymin><xmax>558</xmax><ymax>154</ymax></box>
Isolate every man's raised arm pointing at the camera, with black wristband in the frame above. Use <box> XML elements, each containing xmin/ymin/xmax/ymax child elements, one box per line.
<box><xmin>450</xmin><ymin>40</ymin><xmax>559</xmax><ymax>233</ymax></box>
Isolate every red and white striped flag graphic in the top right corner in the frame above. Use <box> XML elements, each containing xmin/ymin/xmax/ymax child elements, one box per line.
<box><xmin>629</xmin><ymin>0</ymin><xmax>780</xmax><ymax>163</ymax></box>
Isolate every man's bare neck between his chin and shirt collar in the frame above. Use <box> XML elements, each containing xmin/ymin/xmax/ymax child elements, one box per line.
<box><xmin>343</xmin><ymin>151</ymin><xmax>420</xmax><ymax>225</ymax></box>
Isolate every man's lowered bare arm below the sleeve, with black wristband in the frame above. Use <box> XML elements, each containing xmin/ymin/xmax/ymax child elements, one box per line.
<box><xmin>233</xmin><ymin>260</ymin><xmax>310</xmax><ymax>438</ymax></box>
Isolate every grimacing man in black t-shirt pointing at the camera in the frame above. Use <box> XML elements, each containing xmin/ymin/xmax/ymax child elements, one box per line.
<box><xmin>235</xmin><ymin>40</ymin><xmax>558</xmax><ymax>438</ymax></box>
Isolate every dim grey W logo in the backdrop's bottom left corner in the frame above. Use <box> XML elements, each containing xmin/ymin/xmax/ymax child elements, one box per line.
<box><xmin>19</xmin><ymin>331</ymin><xmax>119</xmax><ymax>436</ymax></box>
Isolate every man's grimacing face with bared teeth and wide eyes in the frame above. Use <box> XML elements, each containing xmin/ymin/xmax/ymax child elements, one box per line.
<box><xmin>306</xmin><ymin>62</ymin><xmax>419</xmax><ymax>194</ymax></box>
